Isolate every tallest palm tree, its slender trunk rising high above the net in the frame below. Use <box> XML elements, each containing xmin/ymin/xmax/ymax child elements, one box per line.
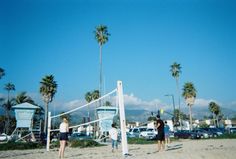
<box><xmin>94</xmin><ymin>25</ymin><xmax>110</xmax><ymax>99</ymax></box>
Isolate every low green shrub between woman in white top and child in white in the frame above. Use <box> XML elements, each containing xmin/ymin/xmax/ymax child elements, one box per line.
<box><xmin>70</xmin><ymin>140</ymin><xmax>102</xmax><ymax>148</ymax></box>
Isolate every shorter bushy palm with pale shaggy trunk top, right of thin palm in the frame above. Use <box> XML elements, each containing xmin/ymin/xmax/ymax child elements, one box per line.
<box><xmin>182</xmin><ymin>82</ymin><xmax>197</xmax><ymax>130</ymax></box>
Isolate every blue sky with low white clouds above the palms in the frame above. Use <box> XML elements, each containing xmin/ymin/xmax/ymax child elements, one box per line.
<box><xmin>0</xmin><ymin>0</ymin><xmax>236</xmax><ymax>113</ymax></box>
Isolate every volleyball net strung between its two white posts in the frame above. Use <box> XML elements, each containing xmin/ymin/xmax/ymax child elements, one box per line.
<box><xmin>46</xmin><ymin>81</ymin><xmax>128</xmax><ymax>155</ymax></box>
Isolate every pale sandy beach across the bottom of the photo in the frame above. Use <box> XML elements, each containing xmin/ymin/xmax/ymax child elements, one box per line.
<box><xmin>0</xmin><ymin>139</ymin><xmax>236</xmax><ymax>159</ymax></box>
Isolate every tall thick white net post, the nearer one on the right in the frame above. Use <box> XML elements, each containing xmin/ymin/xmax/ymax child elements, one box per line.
<box><xmin>117</xmin><ymin>81</ymin><xmax>128</xmax><ymax>155</ymax></box>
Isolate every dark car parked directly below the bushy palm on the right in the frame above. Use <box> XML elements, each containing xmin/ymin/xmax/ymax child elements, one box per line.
<box><xmin>174</xmin><ymin>130</ymin><xmax>200</xmax><ymax>139</ymax></box>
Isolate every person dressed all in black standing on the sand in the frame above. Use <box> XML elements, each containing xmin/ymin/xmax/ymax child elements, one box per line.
<box><xmin>156</xmin><ymin>115</ymin><xmax>165</xmax><ymax>151</ymax></box>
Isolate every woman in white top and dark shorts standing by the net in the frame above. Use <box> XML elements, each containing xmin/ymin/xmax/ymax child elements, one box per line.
<box><xmin>59</xmin><ymin>118</ymin><xmax>69</xmax><ymax>158</ymax></box>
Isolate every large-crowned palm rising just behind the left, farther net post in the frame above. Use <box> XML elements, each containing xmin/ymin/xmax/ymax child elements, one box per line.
<box><xmin>39</xmin><ymin>75</ymin><xmax>57</xmax><ymax>133</ymax></box>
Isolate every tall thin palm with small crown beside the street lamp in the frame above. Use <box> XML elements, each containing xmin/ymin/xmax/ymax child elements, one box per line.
<box><xmin>170</xmin><ymin>62</ymin><xmax>182</xmax><ymax>129</ymax></box>
